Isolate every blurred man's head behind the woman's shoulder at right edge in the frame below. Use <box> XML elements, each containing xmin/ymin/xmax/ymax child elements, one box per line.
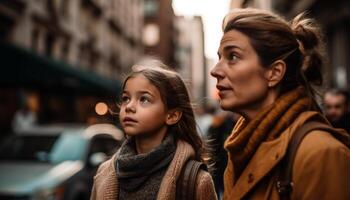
<box><xmin>323</xmin><ymin>89</ymin><xmax>350</xmax><ymax>133</ymax></box>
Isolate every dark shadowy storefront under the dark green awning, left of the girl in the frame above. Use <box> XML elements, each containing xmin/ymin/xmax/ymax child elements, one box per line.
<box><xmin>0</xmin><ymin>44</ymin><xmax>121</xmax><ymax>135</ymax></box>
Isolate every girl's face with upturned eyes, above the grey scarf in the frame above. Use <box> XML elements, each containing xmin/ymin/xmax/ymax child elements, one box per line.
<box><xmin>119</xmin><ymin>74</ymin><xmax>167</xmax><ymax>136</ymax></box>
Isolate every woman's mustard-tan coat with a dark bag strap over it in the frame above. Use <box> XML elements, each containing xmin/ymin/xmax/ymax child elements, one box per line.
<box><xmin>225</xmin><ymin>112</ymin><xmax>350</xmax><ymax>200</ymax></box>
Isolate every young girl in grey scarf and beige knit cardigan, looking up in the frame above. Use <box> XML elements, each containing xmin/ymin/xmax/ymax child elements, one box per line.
<box><xmin>91</xmin><ymin>62</ymin><xmax>216</xmax><ymax>200</ymax></box>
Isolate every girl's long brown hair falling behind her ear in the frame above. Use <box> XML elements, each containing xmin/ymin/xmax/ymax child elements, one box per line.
<box><xmin>122</xmin><ymin>60</ymin><xmax>204</xmax><ymax>161</ymax></box>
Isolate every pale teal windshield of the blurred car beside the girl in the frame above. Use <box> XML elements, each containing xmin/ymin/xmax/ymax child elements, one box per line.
<box><xmin>50</xmin><ymin>134</ymin><xmax>87</xmax><ymax>163</ymax></box>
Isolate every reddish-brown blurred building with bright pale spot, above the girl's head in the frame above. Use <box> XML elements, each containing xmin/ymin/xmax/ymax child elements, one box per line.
<box><xmin>142</xmin><ymin>0</ymin><xmax>177</xmax><ymax>67</ymax></box>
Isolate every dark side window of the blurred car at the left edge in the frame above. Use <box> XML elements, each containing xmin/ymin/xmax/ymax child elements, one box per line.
<box><xmin>0</xmin><ymin>135</ymin><xmax>58</xmax><ymax>162</ymax></box>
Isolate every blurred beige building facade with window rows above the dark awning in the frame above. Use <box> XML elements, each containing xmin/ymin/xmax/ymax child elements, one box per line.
<box><xmin>0</xmin><ymin>0</ymin><xmax>143</xmax><ymax>79</ymax></box>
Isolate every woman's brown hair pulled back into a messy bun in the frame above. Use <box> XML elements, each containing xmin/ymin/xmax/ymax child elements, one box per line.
<box><xmin>222</xmin><ymin>8</ymin><xmax>323</xmax><ymax>99</ymax></box>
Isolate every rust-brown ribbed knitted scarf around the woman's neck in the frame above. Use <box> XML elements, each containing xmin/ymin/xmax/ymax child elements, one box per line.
<box><xmin>224</xmin><ymin>87</ymin><xmax>312</xmax><ymax>185</ymax></box>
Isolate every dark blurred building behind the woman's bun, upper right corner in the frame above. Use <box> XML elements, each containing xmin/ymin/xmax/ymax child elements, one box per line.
<box><xmin>231</xmin><ymin>0</ymin><xmax>350</xmax><ymax>89</ymax></box>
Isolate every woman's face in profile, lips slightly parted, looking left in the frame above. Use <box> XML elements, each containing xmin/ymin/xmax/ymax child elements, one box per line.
<box><xmin>211</xmin><ymin>30</ymin><xmax>269</xmax><ymax>114</ymax></box>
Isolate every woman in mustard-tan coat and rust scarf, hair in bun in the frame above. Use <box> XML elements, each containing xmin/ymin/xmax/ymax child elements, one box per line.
<box><xmin>211</xmin><ymin>8</ymin><xmax>350</xmax><ymax>199</ymax></box>
